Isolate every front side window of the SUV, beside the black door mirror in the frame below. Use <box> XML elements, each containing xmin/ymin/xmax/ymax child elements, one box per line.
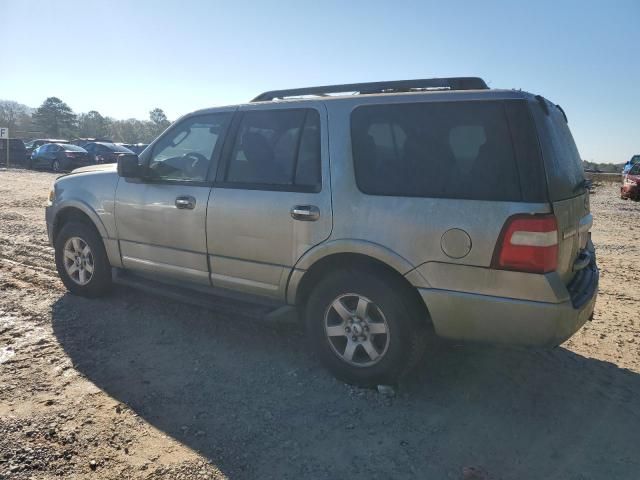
<box><xmin>148</xmin><ymin>112</ymin><xmax>232</xmax><ymax>182</ymax></box>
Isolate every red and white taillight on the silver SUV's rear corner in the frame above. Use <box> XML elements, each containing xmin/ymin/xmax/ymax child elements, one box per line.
<box><xmin>491</xmin><ymin>215</ymin><xmax>558</xmax><ymax>273</ymax></box>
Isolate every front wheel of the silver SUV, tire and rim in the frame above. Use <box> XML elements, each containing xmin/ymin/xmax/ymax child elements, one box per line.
<box><xmin>55</xmin><ymin>222</ymin><xmax>111</xmax><ymax>297</ymax></box>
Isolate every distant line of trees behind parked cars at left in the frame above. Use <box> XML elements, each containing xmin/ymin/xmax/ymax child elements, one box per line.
<box><xmin>0</xmin><ymin>97</ymin><xmax>171</xmax><ymax>143</ymax></box>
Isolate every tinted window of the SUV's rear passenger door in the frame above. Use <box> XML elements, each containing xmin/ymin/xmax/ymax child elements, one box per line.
<box><xmin>225</xmin><ymin>109</ymin><xmax>320</xmax><ymax>190</ymax></box>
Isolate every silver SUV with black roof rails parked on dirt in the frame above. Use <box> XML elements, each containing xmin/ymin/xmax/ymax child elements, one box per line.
<box><xmin>46</xmin><ymin>78</ymin><xmax>598</xmax><ymax>385</ymax></box>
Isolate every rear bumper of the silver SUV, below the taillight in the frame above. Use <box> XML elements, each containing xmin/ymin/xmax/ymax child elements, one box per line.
<box><xmin>419</xmin><ymin>261</ymin><xmax>599</xmax><ymax>347</ymax></box>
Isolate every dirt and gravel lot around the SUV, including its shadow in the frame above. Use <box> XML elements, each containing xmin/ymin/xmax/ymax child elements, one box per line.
<box><xmin>0</xmin><ymin>170</ymin><xmax>640</xmax><ymax>480</ymax></box>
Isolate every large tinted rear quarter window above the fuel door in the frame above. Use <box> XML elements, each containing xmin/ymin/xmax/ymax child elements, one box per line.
<box><xmin>351</xmin><ymin>102</ymin><xmax>521</xmax><ymax>201</ymax></box>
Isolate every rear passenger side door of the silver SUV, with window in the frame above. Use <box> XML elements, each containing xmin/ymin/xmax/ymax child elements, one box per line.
<box><xmin>207</xmin><ymin>102</ymin><xmax>332</xmax><ymax>300</ymax></box>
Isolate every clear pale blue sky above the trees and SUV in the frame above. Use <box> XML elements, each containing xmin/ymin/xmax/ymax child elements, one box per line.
<box><xmin>0</xmin><ymin>0</ymin><xmax>640</xmax><ymax>163</ymax></box>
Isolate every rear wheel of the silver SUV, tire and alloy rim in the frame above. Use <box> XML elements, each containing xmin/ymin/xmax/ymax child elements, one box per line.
<box><xmin>305</xmin><ymin>268</ymin><xmax>427</xmax><ymax>387</ymax></box>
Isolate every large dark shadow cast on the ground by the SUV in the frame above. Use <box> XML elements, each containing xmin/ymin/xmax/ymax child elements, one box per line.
<box><xmin>52</xmin><ymin>288</ymin><xmax>640</xmax><ymax>480</ymax></box>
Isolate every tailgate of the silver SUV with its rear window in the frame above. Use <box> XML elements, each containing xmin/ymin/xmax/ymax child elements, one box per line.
<box><xmin>532</xmin><ymin>97</ymin><xmax>593</xmax><ymax>283</ymax></box>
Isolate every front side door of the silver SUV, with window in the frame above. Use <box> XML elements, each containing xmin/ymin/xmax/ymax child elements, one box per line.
<box><xmin>115</xmin><ymin>110</ymin><xmax>233</xmax><ymax>285</ymax></box>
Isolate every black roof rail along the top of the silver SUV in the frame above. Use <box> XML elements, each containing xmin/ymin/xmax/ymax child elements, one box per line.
<box><xmin>251</xmin><ymin>77</ymin><xmax>489</xmax><ymax>102</ymax></box>
